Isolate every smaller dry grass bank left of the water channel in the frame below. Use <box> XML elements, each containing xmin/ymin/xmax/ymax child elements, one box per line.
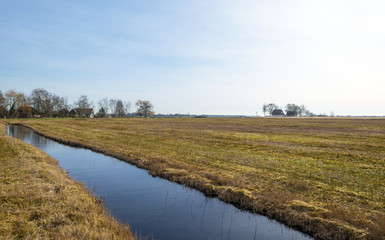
<box><xmin>0</xmin><ymin>121</ymin><xmax>134</xmax><ymax>239</ymax></box>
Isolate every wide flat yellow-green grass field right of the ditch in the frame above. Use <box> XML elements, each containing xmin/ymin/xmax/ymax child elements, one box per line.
<box><xmin>10</xmin><ymin>118</ymin><xmax>385</xmax><ymax>239</ymax></box>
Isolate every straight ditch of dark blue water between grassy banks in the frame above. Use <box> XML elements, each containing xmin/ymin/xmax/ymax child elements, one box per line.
<box><xmin>7</xmin><ymin>126</ymin><xmax>311</xmax><ymax>240</ymax></box>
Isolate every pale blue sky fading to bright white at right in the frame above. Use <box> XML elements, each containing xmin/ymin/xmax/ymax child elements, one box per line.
<box><xmin>0</xmin><ymin>0</ymin><xmax>385</xmax><ymax>116</ymax></box>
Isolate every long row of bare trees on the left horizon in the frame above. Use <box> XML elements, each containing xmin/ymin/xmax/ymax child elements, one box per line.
<box><xmin>0</xmin><ymin>88</ymin><xmax>155</xmax><ymax>117</ymax></box>
